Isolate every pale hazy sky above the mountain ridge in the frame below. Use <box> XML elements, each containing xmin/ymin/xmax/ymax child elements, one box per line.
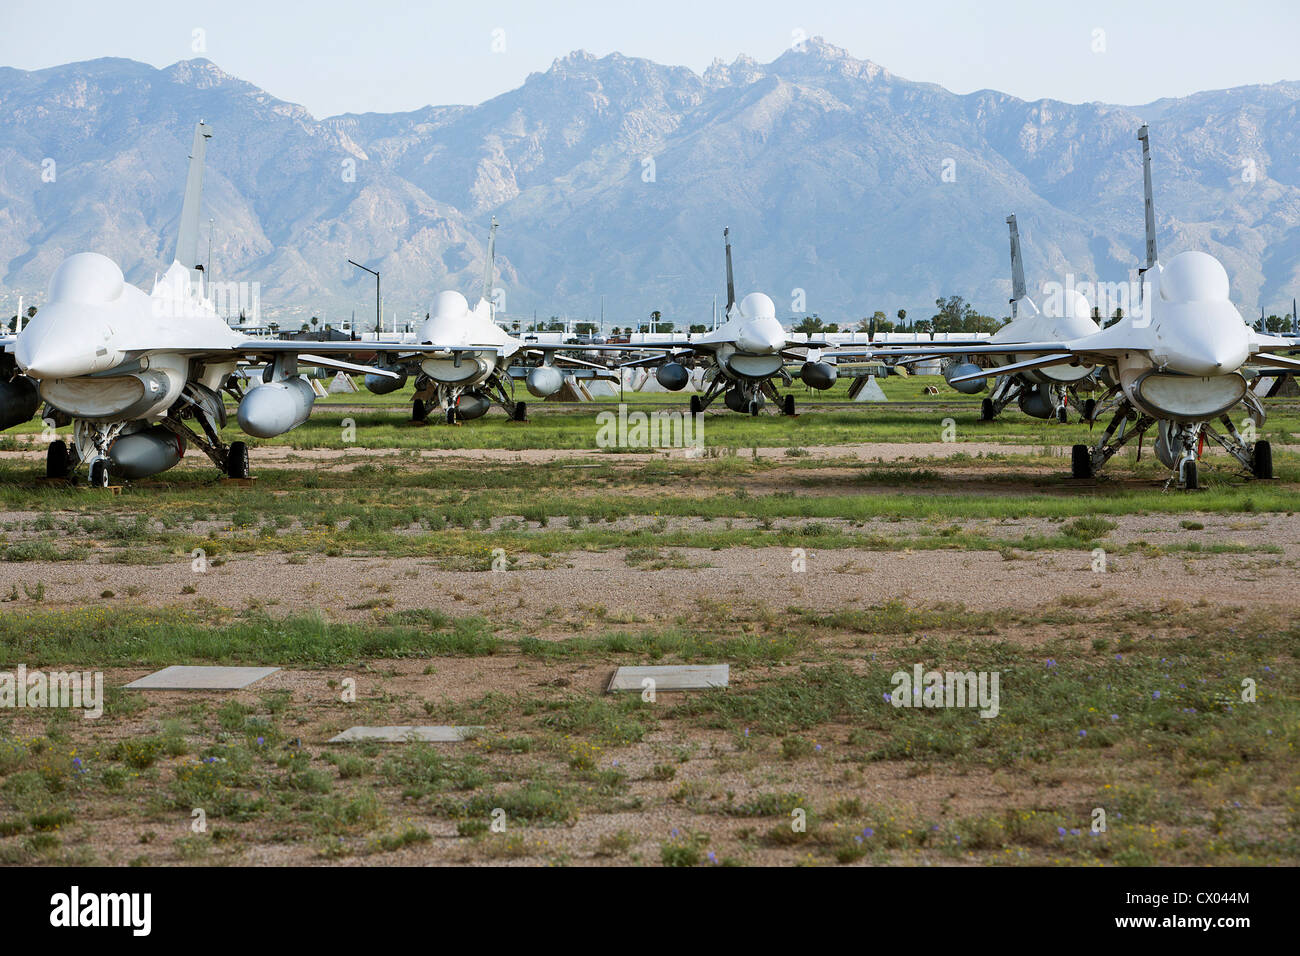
<box><xmin>0</xmin><ymin>0</ymin><xmax>1300</xmax><ymax>117</ymax></box>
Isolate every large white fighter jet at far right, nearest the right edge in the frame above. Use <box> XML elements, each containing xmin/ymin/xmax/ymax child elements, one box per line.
<box><xmin>889</xmin><ymin>126</ymin><xmax>1300</xmax><ymax>489</ymax></box>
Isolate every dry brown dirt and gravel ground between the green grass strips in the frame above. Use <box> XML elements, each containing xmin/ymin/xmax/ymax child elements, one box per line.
<box><xmin>0</xmin><ymin>444</ymin><xmax>1300</xmax><ymax>865</ymax></box>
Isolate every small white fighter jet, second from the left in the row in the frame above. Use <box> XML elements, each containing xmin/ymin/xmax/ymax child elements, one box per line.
<box><xmin>365</xmin><ymin>219</ymin><xmax>606</xmax><ymax>424</ymax></box>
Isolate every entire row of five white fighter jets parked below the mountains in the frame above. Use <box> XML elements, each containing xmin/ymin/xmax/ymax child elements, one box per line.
<box><xmin>0</xmin><ymin>122</ymin><xmax>1300</xmax><ymax>488</ymax></box>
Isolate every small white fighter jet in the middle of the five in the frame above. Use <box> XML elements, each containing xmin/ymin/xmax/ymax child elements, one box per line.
<box><xmin>592</xmin><ymin>229</ymin><xmax>836</xmax><ymax>415</ymax></box>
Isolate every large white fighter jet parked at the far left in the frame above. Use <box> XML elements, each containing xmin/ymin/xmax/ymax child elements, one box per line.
<box><xmin>0</xmin><ymin>121</ymin><xmax>441</xmax><ymax>486</ymax></box>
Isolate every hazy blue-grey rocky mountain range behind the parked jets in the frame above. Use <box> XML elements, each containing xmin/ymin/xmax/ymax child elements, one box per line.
<box><xmin>0</xmin><ymin>38</ymin><xmax>1300</xmax><ymax>328</ymax></box>
